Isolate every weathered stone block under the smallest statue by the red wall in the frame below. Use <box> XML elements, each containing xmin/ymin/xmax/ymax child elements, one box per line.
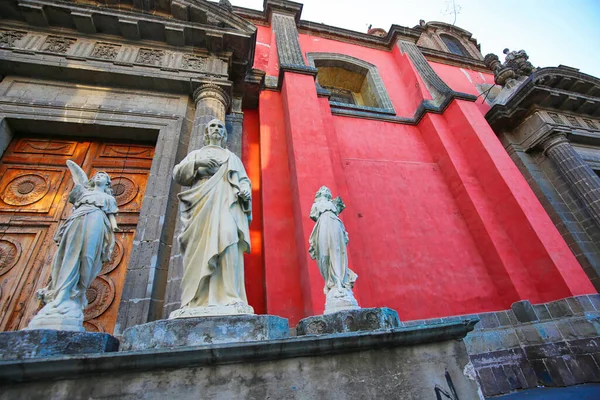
<box><xmin>296</xmin><ymin>308</ymin><xmax>400</xmax><ymax>336</ymax></box>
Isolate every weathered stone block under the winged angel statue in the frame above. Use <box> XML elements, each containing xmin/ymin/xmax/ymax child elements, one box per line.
<box><xmin>0</xmin><ymin>329</ymin><xmax>119</xmax><ymax>360</ymax></box>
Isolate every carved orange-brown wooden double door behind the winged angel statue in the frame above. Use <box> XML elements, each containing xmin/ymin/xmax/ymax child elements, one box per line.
<box><xmin>0</xmin><ymin>136</ymin><xmax>154</xmax><ymax>333</ymax></box>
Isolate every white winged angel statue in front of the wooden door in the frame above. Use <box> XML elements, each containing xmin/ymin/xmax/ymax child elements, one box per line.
<box><xmin>26</xmin><ymin>160</ymin><xmax>119</xmax><ymax>331</ymax></box>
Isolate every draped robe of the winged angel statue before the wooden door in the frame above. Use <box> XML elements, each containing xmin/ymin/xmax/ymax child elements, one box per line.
<box><xmin>42</xmin><ymin>184</ymin><xmax>118</xmax><ymax>309</ymax></box>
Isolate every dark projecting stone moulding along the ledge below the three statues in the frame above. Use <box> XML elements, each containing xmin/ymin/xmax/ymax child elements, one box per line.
<box><xmin>0</xmin><ymin>319</ymin><xmax>479</xmax><ymax>383</ymax></box>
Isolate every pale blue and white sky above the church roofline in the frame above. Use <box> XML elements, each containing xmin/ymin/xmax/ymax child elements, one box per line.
<box><xmin>230</xmin><ymin>0</ymin><xmax>600</xmax><ymax>77</ymax></box>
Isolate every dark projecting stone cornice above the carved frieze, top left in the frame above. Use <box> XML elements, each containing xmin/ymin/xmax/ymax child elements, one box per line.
<box><xmin>0</xmin><ymin>0</ymin><xmax>256</xmax><ymax>74</ymax></box>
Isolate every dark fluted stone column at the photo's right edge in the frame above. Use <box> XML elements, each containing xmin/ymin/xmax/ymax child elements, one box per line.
<box><xmin>539</xmin><ymin>132</ymin><xmax>600</xmax><ymax>226</ymax></box>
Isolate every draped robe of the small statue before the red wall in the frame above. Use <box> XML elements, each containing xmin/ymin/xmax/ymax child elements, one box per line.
<box><xmin>308</xmin><ymin>198</ymin><xmax>358</xmax><ymax>294</ymax></box>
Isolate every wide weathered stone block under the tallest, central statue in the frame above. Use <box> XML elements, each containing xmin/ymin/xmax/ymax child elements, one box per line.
<box><xmin>121</xmin><ymin>315</ymin><xmax>290</xmax><ymax>351</ymax></box>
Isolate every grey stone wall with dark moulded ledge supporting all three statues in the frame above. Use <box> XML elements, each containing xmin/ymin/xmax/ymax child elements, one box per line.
<box><xmin>0</xmin><ymin>321</ymin><xmax>481</xmax><ymax>400</ymax></box>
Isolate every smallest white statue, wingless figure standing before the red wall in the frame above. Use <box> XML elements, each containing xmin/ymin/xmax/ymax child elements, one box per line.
<box><xmin>308</xmin><ymin>186</ymin><xmax>360</xmax><ymax>314</ymax></box>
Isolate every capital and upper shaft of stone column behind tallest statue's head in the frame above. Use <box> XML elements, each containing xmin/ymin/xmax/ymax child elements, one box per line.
<box><xmin>188</xmin><ymin>83</ymin><xmax>231</xmax><ymax>152</ymax></box>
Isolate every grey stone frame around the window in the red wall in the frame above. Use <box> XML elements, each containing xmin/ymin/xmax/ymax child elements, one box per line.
<box><xmin>306</xmin><ymin>52</ymin><xmax>396</xmax><ymax>115</ymax></box>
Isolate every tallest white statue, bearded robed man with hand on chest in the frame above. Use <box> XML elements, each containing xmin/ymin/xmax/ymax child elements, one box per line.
<box><xmin>169</xmin><ymin>119</ymin><xmax>254</xmax><ymax>318</ymax></box>
